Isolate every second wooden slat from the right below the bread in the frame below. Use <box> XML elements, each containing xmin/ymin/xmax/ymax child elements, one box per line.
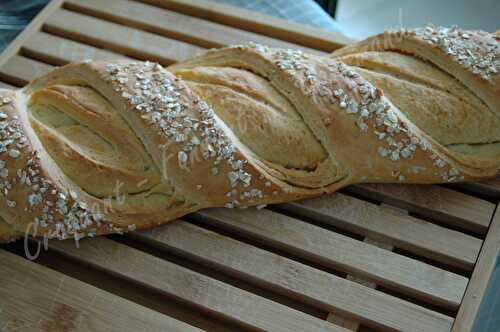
<box><xmin>281</xmin><ymin>193</ymin><xmax>482</xmax><ymax>270</ymax></box>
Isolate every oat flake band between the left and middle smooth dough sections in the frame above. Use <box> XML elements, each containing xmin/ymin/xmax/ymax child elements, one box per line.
<box><xmin>106</xmin><ymin>61</ymin><xmax>256</xmax><ymax>207</ymax></box>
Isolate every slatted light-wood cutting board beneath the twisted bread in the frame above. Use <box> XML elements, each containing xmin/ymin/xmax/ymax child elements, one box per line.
<box><xmin>0</xmin><ymin>0</ymin><xmax>500</xmax><ymax>332</ymax></box>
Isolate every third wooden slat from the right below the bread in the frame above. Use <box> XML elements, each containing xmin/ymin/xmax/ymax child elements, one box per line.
<box><xmin>196</xmin><ymin>209</ymin><xmax>467</xmax><ymax>309</ymax></box>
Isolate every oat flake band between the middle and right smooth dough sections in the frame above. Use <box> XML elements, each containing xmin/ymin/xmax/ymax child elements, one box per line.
<box><xmin>242</xmin><ymin>43</ymin><xmax>462</xmax><ymax>182</ymax></box>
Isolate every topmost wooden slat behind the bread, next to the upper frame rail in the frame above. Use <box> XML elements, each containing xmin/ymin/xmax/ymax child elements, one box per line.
<box><xmin>65</xmin><ymin>0</ymin><xmax>325</xmax><ymax>54</ymax></box>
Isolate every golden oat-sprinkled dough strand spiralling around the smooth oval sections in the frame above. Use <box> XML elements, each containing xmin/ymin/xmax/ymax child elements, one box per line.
<box><xmin>0</xmin><ymin>24</ymin><xmax>499</xmax><ymax>241</ymax></box>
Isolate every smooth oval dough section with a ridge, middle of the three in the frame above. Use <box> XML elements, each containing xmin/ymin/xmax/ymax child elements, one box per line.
<box><xmin>175</xmin><ymin>67</ymin><xmax>327</xmax><ymax>171</ymax></box>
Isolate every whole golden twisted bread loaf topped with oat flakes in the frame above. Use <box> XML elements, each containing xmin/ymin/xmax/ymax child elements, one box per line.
<box><xmin>0</xmin><ymin>27</ymin><xmax>500</xmax><ymax>241</ymax></box>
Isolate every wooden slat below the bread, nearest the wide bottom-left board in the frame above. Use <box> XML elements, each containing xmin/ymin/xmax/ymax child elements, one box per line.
<box><xmin>50</xmin><ymin>237</ymin><xmax>347</xmax><ymax>332</ymax></box>
